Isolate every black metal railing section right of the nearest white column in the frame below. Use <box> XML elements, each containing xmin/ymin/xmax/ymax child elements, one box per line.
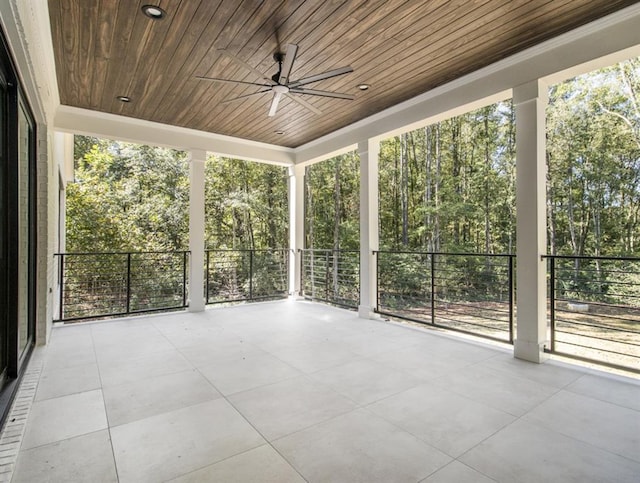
<box><xmin>545</xmin><ymin>255</ymin><xmax>640</xmax><ymax>372</ymax></box>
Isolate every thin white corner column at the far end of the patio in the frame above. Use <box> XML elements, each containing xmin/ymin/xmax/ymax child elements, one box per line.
<box><xmin>289</xmin><ymin>166</ymin><xmax>304</xmax><ymax>298</ymax></box>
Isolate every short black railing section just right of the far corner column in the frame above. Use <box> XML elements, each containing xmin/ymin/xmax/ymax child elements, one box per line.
<box><xmin>299</xmin><ymin>248</ymin><xmax>360</xmax><ymax>308</ymax></box>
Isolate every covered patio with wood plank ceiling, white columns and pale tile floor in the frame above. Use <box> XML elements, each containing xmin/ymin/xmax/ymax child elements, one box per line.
<box><xmin>0</xmin><ymin>0</ymin><xmax>640</xmax><ymax>482</ymax></box>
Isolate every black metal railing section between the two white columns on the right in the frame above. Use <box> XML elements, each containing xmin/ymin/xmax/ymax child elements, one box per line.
<box><xmin>374</xmin><ymin>250</ymin><xmax>515</xmax><ymax>343</ymax></box>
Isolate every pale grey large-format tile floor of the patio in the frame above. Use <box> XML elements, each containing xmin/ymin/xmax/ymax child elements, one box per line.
<box><xmin>12</xmin><ymin>301</ymin><xmax>640</xmax><ymax>483</ymax></box>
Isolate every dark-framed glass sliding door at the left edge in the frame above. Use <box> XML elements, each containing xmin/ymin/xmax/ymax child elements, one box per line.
<box><xmin>0</xmin><ymin>25</ymin><xmax>36</xmax><ymax>425</ymax></box>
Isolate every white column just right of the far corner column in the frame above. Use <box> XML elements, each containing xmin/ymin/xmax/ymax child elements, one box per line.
<box><xmin>358</xmin><ymin>139</ymin><xmax>380</xmax><ymax>319</ymax></box>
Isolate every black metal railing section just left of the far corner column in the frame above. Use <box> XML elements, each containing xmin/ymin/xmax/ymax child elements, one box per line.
<box><xmin>205</xmin><ymin>248</ymin><xmax>290</xmax><ymax>304</ymax></box>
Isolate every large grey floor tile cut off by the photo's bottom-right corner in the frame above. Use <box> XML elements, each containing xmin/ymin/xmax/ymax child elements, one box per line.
<box><xmin>459</xmin><ymin>420</ymin><xmax>640</xmax><ymax>483</ymax></box>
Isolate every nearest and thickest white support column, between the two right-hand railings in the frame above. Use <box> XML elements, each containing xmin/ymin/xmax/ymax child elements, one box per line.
<box><xmin>513</xmin><ymin>81</ymin><xmax>548</xmax><ymax>362</ymax></box>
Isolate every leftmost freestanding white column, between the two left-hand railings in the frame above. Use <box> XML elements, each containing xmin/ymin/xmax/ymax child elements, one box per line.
<box><xmin>189</xmin><ymin>150</ymin><xmax>207</xmax><ymax>312</ymax></box>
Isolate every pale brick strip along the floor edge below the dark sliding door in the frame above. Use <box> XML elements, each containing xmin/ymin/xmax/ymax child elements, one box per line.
<box><xmin>0</xmin><ymin>354</ymin><xmax>44</xmax><ymax>482</ymax></box>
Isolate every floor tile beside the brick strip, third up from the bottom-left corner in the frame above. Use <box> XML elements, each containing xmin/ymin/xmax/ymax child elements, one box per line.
<box><xmin>36</xmin><ymin>363</ymin><xmax>100</xmax><ymax>401</ymax></box>
